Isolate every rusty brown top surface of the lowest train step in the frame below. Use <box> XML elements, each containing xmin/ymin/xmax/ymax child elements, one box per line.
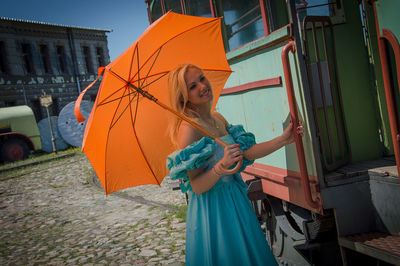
<box><xmin>346</xmin><ymin>233</ymin><xmax>400</xmax><ymax>257</ymax></box>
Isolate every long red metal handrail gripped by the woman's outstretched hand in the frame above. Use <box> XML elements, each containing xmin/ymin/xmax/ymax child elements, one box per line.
<box><xmin>282</xmin><ymin>41</ymin><xmax>321</xmax><ymax>210</ymax></box>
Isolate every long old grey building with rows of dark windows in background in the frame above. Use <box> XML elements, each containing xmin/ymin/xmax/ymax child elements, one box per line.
<box><xmin>0</xmin><ymin>17</ymin><xmax>110</xmax><ymax>121</ymax></box>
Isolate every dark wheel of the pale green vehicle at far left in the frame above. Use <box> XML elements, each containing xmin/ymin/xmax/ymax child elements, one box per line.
<box><xmin>1</xmin><ymin>138</ymin><xmax>29</xmax><ymax>162</ymax></box>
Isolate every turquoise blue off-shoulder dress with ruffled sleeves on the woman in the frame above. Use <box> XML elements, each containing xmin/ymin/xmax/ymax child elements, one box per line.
<box><xmin>167</xmin><ymin>126</ymin><xmax>277</xmax><ymax>265</ymax></box>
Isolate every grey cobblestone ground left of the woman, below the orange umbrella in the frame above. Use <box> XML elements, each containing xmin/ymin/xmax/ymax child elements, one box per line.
<box><xmin>0</xmin><ymin>154</ymin><xmax>186</xmax><ymax>265</ymax></box>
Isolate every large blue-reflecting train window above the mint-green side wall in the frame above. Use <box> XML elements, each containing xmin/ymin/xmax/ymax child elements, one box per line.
<box><xmin>222</xmin><ymin>0</ymin><xmax>264</xmax><ymax>50</ymax></box>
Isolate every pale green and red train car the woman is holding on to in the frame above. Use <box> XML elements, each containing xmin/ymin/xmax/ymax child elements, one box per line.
<box><xmin>146</xmin><ymin>0</ymin><xmax>400</xmax><ymax>265</ymax></box>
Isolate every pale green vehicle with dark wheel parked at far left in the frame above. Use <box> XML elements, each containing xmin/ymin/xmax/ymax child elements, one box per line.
<box><xmin>0</xmin><ymin>105</ymin><xmax>42</xmax><ymax>162</ymax></box>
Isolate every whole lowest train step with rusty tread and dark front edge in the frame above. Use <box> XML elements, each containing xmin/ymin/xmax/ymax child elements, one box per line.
<box><xmin>339</xmin><ymin>232</ymin><xmax>400</xmax><ymax>265</ymax></box>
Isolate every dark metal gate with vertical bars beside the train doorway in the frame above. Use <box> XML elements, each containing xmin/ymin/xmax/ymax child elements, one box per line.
<box><xmin>302</xmin><ymin>16</ymin><xmax>351</xmax><ymax>171</ymax></box>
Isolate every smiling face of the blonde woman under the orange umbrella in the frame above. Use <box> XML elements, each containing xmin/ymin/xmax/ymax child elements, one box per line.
<box><xmin>185</xmin><ymin>67</ymin><xmax>213</xmax><ymax>105</ymax></box>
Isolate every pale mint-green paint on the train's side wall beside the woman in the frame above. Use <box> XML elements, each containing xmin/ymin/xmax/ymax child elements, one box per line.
<box><xmin>217</xmin><ymin>28</ymin><xmax>316</xmax><ymax>175</ymax></box>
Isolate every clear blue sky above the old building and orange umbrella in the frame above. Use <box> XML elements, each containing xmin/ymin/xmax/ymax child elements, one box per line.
<box><xmin>0</xmin><ymin>0</ymin><xmax>149</xmax><ymax>60</ymax></box>
